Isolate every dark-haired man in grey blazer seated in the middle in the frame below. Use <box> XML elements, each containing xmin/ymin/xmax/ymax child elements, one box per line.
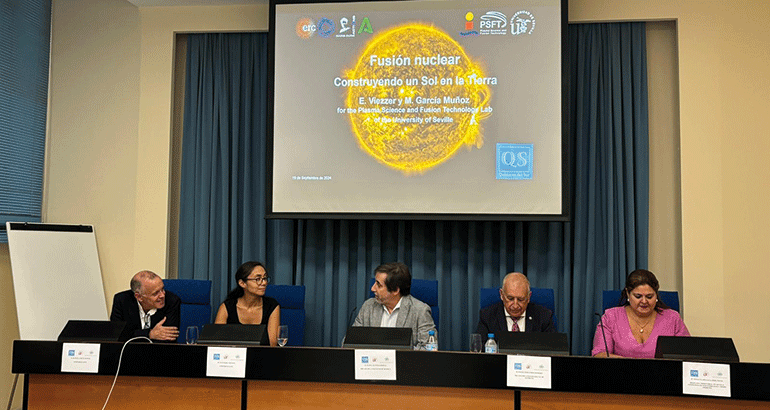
<box><xmin>353</xmin><ymin>262</ymin><xmax>438</xmax><ymax>349</ymax></box>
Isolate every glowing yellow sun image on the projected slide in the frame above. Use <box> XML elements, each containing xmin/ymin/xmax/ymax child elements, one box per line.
<box><xmin>344</xmin><ymin>23</ymin><xmax>488</xmax><ymax>175</ymax></box>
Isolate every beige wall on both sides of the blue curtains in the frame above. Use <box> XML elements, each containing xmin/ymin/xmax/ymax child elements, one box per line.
<box><xmin>0</xmin><ymin>0</ymin><xmax>770</xmax><ymax>400</ymax></box>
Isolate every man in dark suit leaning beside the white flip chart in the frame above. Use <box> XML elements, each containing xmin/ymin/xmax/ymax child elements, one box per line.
<box><xmin>110</xmin><ymin>270</ymin><xmax>182</xmax><ymax>342</ymax></box>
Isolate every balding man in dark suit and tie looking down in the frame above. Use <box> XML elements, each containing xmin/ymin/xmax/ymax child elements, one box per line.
<box><xmin>476</xmin><ymin>272</ymin><xmax>556</xmax><ymax>338</ymax></box>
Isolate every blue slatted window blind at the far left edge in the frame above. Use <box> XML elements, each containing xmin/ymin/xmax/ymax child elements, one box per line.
<box><xmin>0</xmin><ymin>0</ymin><xmax>51</xmax><ymax>243</ymax></box>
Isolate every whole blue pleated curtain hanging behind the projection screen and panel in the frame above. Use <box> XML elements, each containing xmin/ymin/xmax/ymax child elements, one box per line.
<box><xmin>179</xmin><ymin>23</ymin><xmax>648</xmax><ymax>354</ymax></box>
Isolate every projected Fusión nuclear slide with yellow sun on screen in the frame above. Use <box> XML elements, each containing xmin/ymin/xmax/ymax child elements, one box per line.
<box><xmin>268</xmin><ymin>0</ymin><xmax>566</xmax><ymax>219</ymax></box>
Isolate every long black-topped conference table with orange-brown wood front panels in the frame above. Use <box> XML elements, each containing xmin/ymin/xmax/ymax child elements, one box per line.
<box><xmin>12</xmin><ymin>340</ymin><xmax>770</xmax><ymax>410</ymax></box>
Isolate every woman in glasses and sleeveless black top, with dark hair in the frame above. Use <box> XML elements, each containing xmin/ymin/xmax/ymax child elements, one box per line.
<box><xmin>214</xmin><ymin>262</ymin><xmax>281</xmax><ymax>346</ymax></box>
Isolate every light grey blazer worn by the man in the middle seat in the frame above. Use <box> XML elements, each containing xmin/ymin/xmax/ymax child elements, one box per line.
<box><xmin>353</xmin><ymin>295</ymin><xmax>438</xmax><ymax>350</ymax></box>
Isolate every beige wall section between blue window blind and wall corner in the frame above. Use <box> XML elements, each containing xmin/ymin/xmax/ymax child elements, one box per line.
<box><xmin>43</xmin><ymin>0</ymin><xmax>142</xmax><ymax>314</ymax></box>
